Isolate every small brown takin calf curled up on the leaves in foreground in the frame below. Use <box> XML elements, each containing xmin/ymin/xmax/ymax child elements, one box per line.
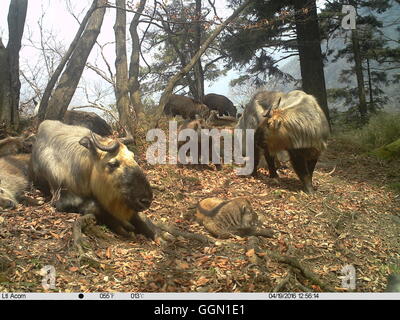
<box><xmin>196</xmin><ymin>198</ymin><xmax>273</xmax><ymax>239</ymax></box>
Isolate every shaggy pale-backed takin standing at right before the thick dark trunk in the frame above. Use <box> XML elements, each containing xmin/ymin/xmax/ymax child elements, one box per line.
<box><xmin>251</xmin><ymin>90</ymin><xmax>330</xmax><ymax>193</ymax></box>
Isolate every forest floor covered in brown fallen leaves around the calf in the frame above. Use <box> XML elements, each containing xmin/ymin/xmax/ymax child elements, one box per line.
<box><xmin>0</xmin><ymin>133</ymin><xmax>400</xmax><ymax>292</ymax></box>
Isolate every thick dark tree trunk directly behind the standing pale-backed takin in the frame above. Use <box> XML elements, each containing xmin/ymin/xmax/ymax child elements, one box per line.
<box><xmin>294</xmin><ymin>0</ymin><xmax>329</xmax><ymax>121</ymax></box>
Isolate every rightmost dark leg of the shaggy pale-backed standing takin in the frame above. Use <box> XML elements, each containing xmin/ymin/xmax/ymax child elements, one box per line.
<box><xmin>288</xmin><ymin>149</ymin><xmax>315</xmax><ymax>193</ymax></box>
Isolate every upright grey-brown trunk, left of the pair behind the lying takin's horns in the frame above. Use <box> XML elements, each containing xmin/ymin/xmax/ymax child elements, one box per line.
<box><xmin>114</xmin><ymin>0</ymin><xmax>136</xmax><ymax>137</ymax></box>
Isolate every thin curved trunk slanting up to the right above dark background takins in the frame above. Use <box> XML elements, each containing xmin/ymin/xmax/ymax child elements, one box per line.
<box><xmin>155</xmin><ymin>0</ymin><xmax>251</xmax><ymax>125</ymax></box>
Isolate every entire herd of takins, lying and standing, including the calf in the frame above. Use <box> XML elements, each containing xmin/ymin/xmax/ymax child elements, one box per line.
<box><xmin>0</xmin><ymin>90</ymin><xmax>330</xmax><ymax>239</ymax></box>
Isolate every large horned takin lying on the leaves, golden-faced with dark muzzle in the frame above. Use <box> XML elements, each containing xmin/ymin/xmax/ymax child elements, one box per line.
<box><xmin>31</xmin><ymin>120</ymin><xmax>155</xmax><ymax>239</ymax></box>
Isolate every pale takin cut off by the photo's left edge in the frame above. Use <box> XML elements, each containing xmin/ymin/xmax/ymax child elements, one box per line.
<box><xmin>0</xmin><ymin>154</ymin><xmax>31</xmax><ymax>209</ymax></box>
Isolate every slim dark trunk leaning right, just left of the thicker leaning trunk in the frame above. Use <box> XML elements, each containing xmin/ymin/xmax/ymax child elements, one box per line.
<box><xmin>38</xmin><ymin>0</ymin><xmax>98</xmax><ymax>121</ymax></box>
